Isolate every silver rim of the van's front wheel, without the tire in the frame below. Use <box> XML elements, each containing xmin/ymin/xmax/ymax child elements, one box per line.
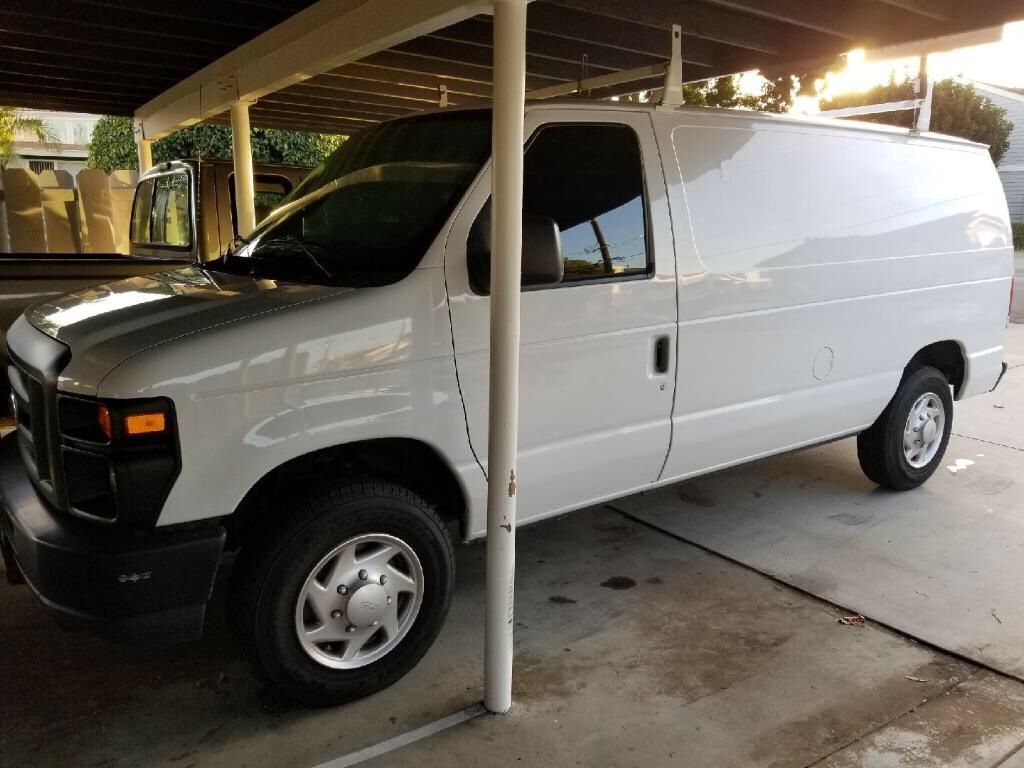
<box><xmin>295</xmin><ymin>534</ymin><xmax>424</xmax><ymax>670</ymax></box>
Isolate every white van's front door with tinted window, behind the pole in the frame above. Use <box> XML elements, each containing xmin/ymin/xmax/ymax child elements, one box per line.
<box><xmin>444</xmin><ymin>108</ymin><xmax>677</xmax><ymax>535</ymax></box>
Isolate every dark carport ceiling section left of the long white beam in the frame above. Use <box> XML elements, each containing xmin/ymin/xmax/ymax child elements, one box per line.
<box><xmin>0</xmin><ymin>0</ymin><xmax>312</xmax><ymax>115</ymax></box>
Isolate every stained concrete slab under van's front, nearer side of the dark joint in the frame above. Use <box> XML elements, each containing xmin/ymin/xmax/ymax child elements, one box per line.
<box><xmin>8</xmin><ymin>508</ymin><xmax>1024</xmax><ymax>768</ymax></box>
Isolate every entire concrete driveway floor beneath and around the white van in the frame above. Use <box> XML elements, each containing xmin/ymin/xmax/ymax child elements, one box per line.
<box><xmin>0</xmin><ymin>315</ymin><xmax>1024</xmax><ymax>768</ymax></box>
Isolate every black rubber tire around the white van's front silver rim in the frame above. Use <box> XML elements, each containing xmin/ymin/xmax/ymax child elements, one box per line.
<box><xmin>230</xmin><ymin>479</ymin><xmax>455</xmax><ymax>707</ymax></box>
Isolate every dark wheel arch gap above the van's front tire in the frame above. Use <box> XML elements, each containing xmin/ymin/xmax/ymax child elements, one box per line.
<box><xmin>221</xmin><ymin>437</ymin><xmax>469</xmax><ymax>549</ymax></box>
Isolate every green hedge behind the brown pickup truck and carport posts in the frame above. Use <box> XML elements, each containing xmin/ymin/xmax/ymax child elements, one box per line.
<box><xmin>88</xmin><ymin>117</ymin><xmax>344</xmax><ymax>173</ymax></box>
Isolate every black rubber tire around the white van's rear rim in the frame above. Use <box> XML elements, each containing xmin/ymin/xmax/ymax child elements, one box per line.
<box><xmin>857</xmin><ymin>366</ymin><xmax>953</xmax><ymax>490</ymax></box>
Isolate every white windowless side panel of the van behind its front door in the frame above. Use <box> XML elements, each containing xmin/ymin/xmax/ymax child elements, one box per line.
<box><xmin>653</xmin><ymin>113</ymin><xmax>1013</xmax><ymax>479</ymax></box>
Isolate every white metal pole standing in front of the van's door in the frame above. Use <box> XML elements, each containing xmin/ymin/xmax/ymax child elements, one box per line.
<box><xmin>483</xmin><ymin>0</ymin><xmax>526</xmax><ymax>713</ymax></box>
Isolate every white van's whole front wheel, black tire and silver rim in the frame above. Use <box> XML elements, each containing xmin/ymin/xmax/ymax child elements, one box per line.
<box><xmin>231</xmin><ymin>480</ymin><xmax>455</xmax><ymax>707</ymax></box>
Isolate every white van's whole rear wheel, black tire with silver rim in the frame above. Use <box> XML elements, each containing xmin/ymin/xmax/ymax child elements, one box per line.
<box><xmin>857</xmin><ymin>366</ymin><xmax>953</xmax><ymax>490</ymax></box>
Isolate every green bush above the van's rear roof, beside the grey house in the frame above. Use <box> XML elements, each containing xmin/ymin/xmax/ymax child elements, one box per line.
<box><xmin>821</xmin><ymin>78</ymin><xmax>1014</xmax><ymax>163</ymax></box>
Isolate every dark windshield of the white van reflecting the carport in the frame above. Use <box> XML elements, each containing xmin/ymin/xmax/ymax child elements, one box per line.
<box><xmin>209</xmin><ymin>111</ymin><xmax>490</xmax><ymax>287</ymax></box>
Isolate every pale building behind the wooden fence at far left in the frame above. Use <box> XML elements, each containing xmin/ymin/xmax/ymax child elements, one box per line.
<box><xmin>9</xmin><ymin>110</ymin><xmax>99</xmax><ymax>176</ymax></box>
